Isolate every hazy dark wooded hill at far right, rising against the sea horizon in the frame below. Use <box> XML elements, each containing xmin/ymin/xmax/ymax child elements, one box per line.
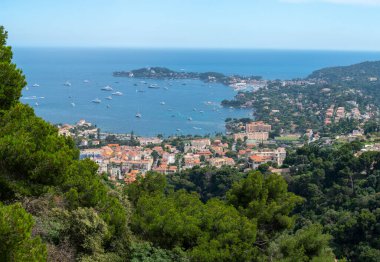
<box><xmin>308</xmin><ymin>61</ymin><xmax>380</xmax><ymax>84</ymax></box>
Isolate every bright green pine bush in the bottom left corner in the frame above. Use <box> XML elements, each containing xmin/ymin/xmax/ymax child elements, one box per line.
<box><xmin>0</xmin><ymin>203</ymin><xmax>46</xmax><ymax>261</ymax></box>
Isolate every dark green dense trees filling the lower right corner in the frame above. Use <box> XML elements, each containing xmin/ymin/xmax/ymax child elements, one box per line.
<box><xmin>286</xmin><ymin>142</ymin><xmax>380</xmax><ymax>261</ymax></box>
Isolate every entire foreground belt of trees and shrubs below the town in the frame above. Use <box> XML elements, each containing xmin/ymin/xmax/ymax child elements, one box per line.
<box><xmin>0</xmin><ymin>27</ymin><xmax>380</xmax><ymax>261</ymax></box>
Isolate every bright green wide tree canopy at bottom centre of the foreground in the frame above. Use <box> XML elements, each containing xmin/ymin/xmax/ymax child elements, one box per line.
<box><xmin>131</xmin><ymin>174</ymin><xmax>256</xmax><ymax>261</ymax></box>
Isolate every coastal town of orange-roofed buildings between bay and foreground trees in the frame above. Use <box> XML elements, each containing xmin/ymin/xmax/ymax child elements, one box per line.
<box><xmin>58</xmin><ymin>114</ymin><xmax>380</xmax><ymax>184</ymax></box>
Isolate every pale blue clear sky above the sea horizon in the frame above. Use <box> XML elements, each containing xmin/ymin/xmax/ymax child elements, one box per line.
<box><xmin>0</xmin><ymin>0</ymin><xmax>380</xmax><ymax>51</ymax></box>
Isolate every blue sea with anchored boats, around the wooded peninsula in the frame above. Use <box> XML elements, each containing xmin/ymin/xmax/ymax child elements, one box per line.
<box><xmin>13</xmin><ymin>47</ymin><xmax>380</xmax><ymax>136</ymax></box>
